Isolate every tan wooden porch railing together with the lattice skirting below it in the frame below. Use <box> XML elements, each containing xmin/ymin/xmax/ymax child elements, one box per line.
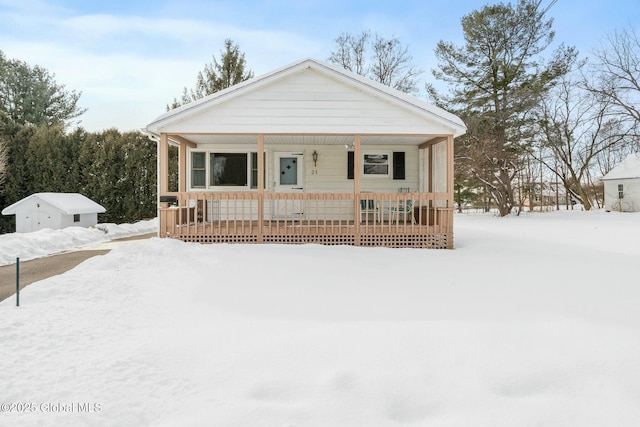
<box><xmin>160</xmin><ymin>192</ymin><xmax>453</xmax><ymax>248</ymax></box>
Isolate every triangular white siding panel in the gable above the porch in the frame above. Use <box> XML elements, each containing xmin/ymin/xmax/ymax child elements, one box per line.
<box><xmin>158</xmin><ymin>69</ymin><xmax>453</xmax><ymax>134</ymax></box>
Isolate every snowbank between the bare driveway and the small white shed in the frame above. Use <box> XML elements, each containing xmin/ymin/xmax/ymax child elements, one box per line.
<box><xmin>0</xmin><ymin>218</ymin><xmax>158</xmax><ymax>265</ymax></box>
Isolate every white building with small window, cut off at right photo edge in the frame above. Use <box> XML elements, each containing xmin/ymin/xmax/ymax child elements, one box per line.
<box><xmin>602</xmin><ymin>153</ymin><xmax>640</xmax><ymax>212</ymax></box>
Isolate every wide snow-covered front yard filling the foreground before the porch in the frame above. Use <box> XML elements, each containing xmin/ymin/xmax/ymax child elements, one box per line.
<box><xmin>0</xmin><ymin>211</ymin><xmax>640</xmax><ymax>427</ymax></box>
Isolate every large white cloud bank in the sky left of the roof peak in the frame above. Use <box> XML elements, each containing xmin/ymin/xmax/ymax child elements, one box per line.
<box><xmin>0</xmin><ymin>0</ymin><xmax>323</xmax><ymax>130</ymax></box>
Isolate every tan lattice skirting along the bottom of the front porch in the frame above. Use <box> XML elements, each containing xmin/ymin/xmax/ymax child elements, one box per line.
<box><xmin>170</xmin><ymin>233</ymin><xmax>453</xmax><ymax>249</ymax></box>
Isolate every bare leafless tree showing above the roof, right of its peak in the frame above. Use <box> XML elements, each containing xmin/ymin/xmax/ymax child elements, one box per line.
<box><xmin>328</xmin><ymin>31</ymin><xmax>422</xmax><ymax>93</ymax></box>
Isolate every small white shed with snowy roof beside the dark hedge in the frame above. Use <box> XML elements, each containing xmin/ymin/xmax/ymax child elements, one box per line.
<box><xmin>2</xmin><ymin>193</ymin><xmax>105</xmax><ymax>233</ymax></box>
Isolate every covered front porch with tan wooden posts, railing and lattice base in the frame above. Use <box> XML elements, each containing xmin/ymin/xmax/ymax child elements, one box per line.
<box><xmin>159</xmin><ymin>134</ymin><xmax>453</xmax><ymax>249</ymax></box>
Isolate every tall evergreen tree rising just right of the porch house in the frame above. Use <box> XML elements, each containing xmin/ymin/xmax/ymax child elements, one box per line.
<box><xmin>427</xmin><ymin>0</ymin><xmax>577</xmax><ymax>215</ymax></box>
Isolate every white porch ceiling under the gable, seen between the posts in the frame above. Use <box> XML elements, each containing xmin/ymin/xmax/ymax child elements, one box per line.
<box><xmin>168</xmin><ymin>134</ymin><xmax>442</xmax><ymax>145</ymax></box>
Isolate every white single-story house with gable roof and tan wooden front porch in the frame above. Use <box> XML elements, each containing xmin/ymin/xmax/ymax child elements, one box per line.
<box><xmin>143</xmin><ymin>59</ymin><xmax>466</xmax><ymax>248</ymax></box>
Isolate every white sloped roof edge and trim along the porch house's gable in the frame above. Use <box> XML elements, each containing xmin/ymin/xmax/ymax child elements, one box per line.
<box><xmin>145</xmin><ymin>58</ymin><xmax>466</xmax><ymax>136</ymax></box>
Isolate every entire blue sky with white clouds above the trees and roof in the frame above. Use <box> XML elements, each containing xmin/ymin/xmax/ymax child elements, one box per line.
<box><xmin>0</xmin><ymin>0</ymin><xmax>640</xmax><ymax>131</ymax></box>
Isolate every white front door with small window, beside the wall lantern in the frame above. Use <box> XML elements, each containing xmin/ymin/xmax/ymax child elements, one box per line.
<box><xmin>273</xmin><ymin>152</ymin><xmax>304</xmax><ymax>219</ymax></box>
